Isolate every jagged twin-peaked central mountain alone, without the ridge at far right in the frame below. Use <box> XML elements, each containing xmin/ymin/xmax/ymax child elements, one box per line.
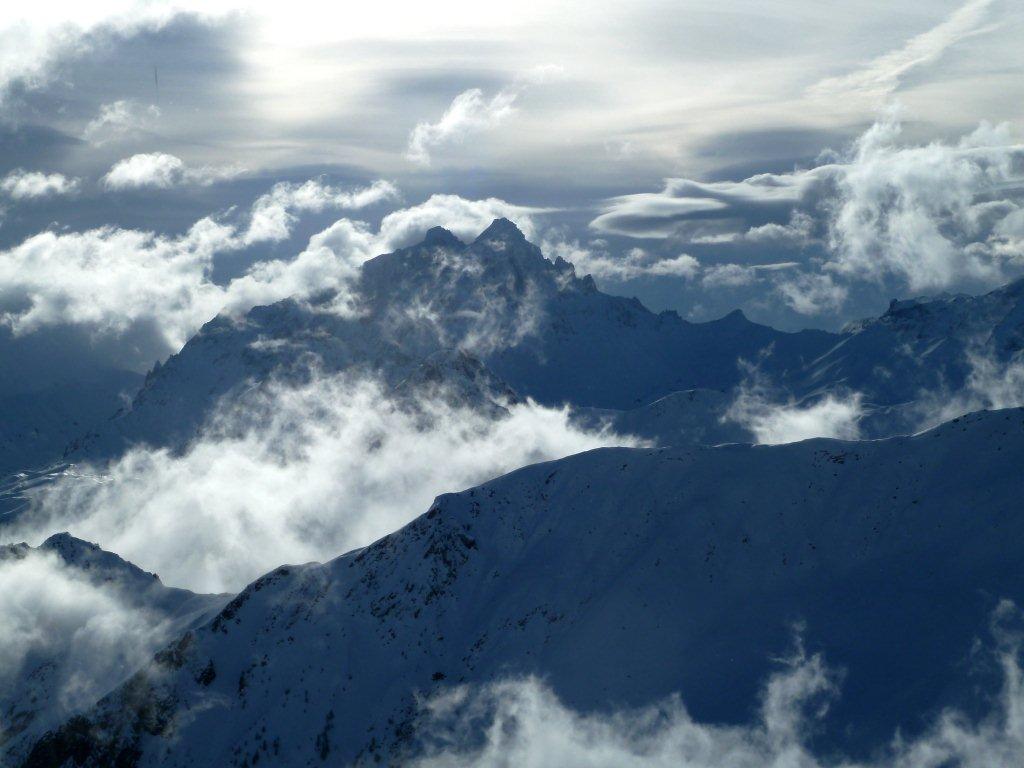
<box><xmin>70</xmin><ymin>219</ymin><xmax>835</xmax><ymax>466</ymax></box>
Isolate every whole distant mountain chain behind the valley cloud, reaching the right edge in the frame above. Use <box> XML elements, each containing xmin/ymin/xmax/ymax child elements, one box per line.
<box><xmin>54</xmin><ymin>219</ymin><xmax>1024</xmax><ymax>468</ymax></box>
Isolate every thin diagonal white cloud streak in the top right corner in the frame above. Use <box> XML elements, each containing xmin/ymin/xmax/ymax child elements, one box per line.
<box><xmin>809</xmin><ymin>0</ymin><xmax>994</xmax><ymax>98</ymax></box>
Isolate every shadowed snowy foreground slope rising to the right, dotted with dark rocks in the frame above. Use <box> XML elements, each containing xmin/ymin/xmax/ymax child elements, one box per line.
<box><xmin>27</xmin><ymin>410</ymin><xmax>1024</xmax><ymax>766</ymax></box>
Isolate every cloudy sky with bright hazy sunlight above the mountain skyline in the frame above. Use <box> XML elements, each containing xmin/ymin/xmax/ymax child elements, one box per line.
<box><xmin>0</xmin><ymin>0</ymin><xmax>1024</xmax><ymax>382</ymax></box>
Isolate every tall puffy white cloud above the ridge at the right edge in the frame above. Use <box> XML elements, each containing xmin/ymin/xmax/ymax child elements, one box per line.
<box><xmin>826</xmin><ymin>120</ymin><xmax>1024</xmax><ymax>291</ymax></box>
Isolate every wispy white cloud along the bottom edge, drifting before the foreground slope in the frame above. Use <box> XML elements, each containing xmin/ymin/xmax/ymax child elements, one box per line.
<box><xmin>412</xmin><ymin>601</ymin><xmax>1024</xmax><ymax>768</ymax></box>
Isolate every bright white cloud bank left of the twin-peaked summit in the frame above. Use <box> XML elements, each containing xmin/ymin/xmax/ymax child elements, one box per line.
<box><xmin>0</xmin><ymin>180</ymin><xmax>396</xmax><ymax>354</ymax></box>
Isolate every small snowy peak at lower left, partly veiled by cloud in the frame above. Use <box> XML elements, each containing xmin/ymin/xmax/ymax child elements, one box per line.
<box><xmin>0</xmin><ymin>534</ymin><xmax>230</xmax><ymax>765</ymax></box>
